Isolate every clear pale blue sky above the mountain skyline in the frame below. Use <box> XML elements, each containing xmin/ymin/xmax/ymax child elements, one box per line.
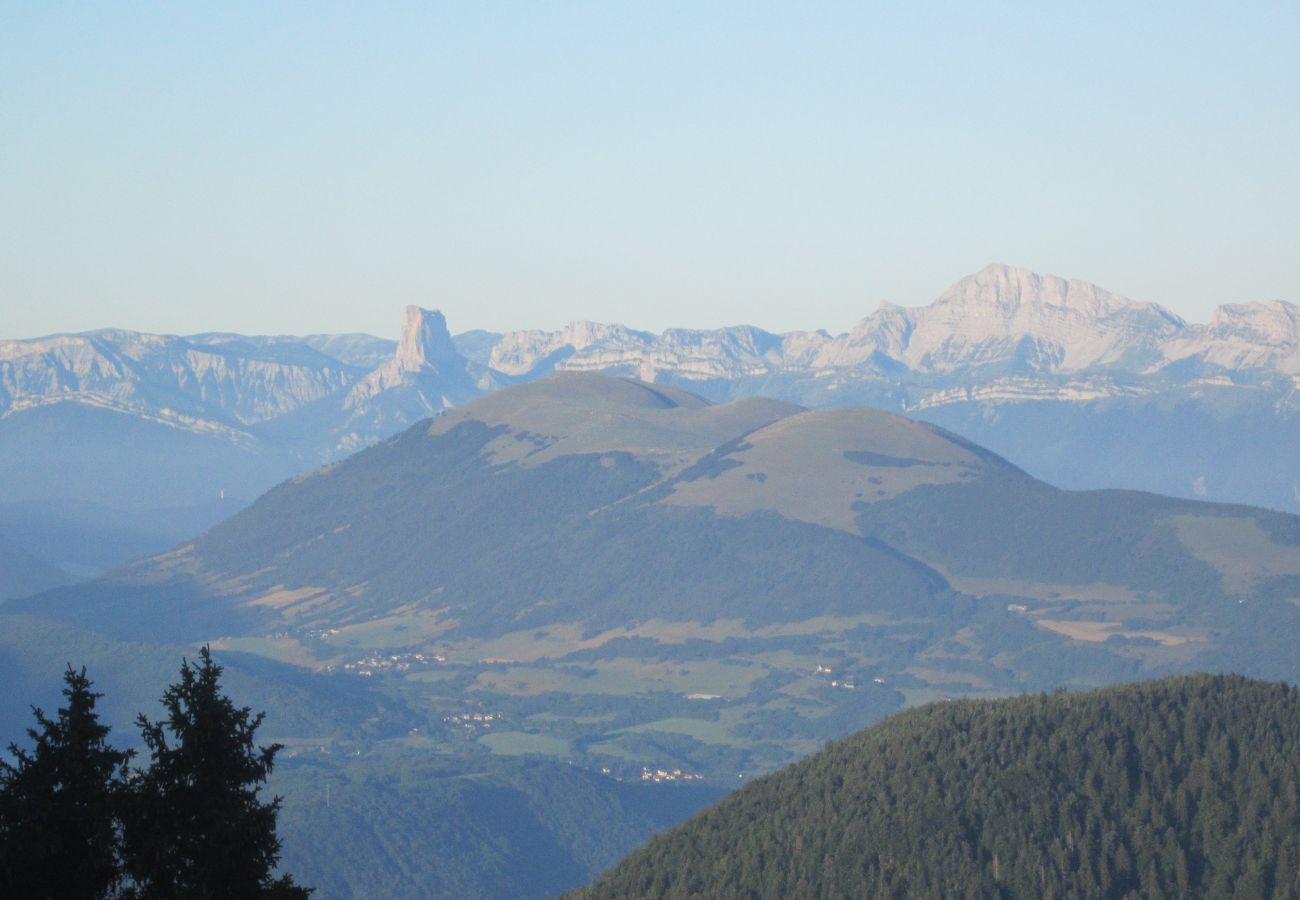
<box><xmin>0</xmin><ymin>0</ymin><xmax>1300</xmax><ymax>337</ymax></box>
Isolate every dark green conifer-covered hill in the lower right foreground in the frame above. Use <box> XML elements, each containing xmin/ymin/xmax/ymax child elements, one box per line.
<box><xmin>571</xmin><ymin>675</ymin><xmax>1300</xmax><ymax>900</ymax></box>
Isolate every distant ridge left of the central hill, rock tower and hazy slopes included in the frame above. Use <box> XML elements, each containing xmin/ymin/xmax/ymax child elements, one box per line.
<box><xmin>0</xmin><ymin>307</ymin><xmax>478</xmax><ymax>520</ymax></box>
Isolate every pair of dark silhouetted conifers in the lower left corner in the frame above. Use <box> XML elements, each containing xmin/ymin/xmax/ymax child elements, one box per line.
<box><xmin>0</xmin><ymin>648</ymin><xmax>311</xmax><ymax>900</ymax></box>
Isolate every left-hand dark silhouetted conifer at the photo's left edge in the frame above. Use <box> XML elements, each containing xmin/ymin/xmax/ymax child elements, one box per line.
<box><xmin>0</xmin><ymin>666</ymin><xmax>130</xmax><ymax>899</ymax></box>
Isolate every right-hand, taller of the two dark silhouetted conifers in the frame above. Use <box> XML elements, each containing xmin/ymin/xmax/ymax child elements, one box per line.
<box><xmin>122</xmin><ymin>646</ymin><xmax>311</xmax><ymax>900</ymax></box>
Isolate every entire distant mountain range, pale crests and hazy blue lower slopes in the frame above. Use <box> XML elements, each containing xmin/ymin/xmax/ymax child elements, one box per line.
<box><xmin>0</xmin><ymin>265</ymin><xmax>1300</xmax><ymax>580</ymax></box>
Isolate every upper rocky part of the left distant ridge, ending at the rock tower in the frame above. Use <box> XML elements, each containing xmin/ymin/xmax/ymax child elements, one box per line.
<box><xmin>0</xmin><ymin>307</ymin><xmax>494</xmax><ymax>460</ymax></box>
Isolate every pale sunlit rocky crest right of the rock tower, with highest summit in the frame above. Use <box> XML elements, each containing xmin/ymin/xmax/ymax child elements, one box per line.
<box><xmin>489</xmin><ymin>265</ymin><xmax>1300</xmax><ymax>387</ymax></box>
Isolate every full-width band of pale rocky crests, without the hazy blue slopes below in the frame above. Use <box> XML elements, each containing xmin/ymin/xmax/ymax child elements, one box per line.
<box><xmin>0</xmin><ymin>265</ymin><xmax>1300</xmax><ymax>449</ymax></box>
